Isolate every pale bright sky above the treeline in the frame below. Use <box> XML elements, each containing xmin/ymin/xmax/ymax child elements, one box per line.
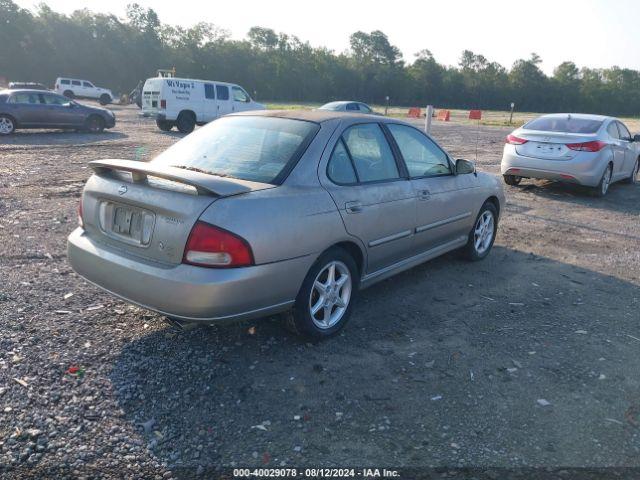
<box><xmin>16</xmin><ymin>0</ymin><xmax>640</xmax><ymax>73</ymax></box>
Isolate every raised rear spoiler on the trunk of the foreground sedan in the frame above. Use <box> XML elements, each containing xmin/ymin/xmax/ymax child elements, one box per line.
<box><xmin>89</xmin><ymin>159</ymin><xmax>275</xmax><ymax>197</ymax></box>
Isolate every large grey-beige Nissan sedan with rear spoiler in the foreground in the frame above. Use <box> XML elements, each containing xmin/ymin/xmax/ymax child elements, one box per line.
<box><xmin>68</xmin><ymin>111</ymin><xmax>504</xmax><ymax>338</ymax></box>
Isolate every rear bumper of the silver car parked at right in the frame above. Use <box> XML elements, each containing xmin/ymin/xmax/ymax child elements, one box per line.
<box><xmin>500</xmin><ymin>145</ymin><xmax>607</xmax><ymax>187</ymax></box>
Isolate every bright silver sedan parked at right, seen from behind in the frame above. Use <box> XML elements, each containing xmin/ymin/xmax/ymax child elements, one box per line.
<box><xmin>501</xmin><ymin>113</ymin><xmax>640</xmax><ymax>196</ymax></box>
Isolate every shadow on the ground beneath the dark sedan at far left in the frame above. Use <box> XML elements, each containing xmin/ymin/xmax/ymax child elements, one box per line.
<box><xmin>0</xmin><ymin>129</ymin><xmax>129</xmax><ymax>147</ymax></box>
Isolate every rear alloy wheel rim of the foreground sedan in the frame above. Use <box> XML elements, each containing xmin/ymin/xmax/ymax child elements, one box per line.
<box><xmin>309</xmin><ymin>260</ymin><xmax>352</xmax><ymax>329</ymax></box>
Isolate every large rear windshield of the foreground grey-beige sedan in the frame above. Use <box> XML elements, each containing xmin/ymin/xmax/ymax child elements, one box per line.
<box><xmin>153</xmin><ymin>116</ymin><xmax>320</xmax><ymax>184</ymax></box>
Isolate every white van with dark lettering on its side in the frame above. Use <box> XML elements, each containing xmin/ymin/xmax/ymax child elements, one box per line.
<box><xmin>142</xmin><ymin>77</ymin><xmax>265</xmax><ymax>133</ymax></box>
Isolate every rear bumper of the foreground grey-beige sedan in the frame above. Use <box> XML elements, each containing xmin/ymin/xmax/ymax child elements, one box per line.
<box><xmin>67</xmin><ymin>228</ymin><xmax>315</xmax><ymax>323</ymax></box>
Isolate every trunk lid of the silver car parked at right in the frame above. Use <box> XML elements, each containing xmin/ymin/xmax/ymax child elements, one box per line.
<box><xmin>515</xmin><ymin>130</ymin><xmax>597</xmax><ymax>160</ymax></box>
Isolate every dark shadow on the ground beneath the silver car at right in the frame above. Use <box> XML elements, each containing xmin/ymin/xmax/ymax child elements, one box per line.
<box><xmin>505</xmin><ymin>179</ymin><xmax>640</xmax><ymax>213</ymax></box>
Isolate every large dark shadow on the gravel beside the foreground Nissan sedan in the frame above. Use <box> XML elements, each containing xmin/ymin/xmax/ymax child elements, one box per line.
<box><xmin>110</xmin><ymin>247</ymin><xmax>640</xmax><ymax>475</ymax></box>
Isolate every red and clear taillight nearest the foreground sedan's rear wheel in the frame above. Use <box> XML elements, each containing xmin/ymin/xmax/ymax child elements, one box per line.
<box><xmin>182</xmin><ymin>221</ymin><xmax>254</xmax><ymax>268</ymax></box>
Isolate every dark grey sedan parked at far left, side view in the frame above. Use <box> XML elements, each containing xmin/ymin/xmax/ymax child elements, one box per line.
<box><xmin>0</xmin><ymin>89</ymin><xmax>116</xmax><ymax>135</ymax></box>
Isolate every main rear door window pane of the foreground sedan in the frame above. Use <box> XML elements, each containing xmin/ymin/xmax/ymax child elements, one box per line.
<box><xmin>342</xmin><ymin>123</ymin><xmax>400</xmax><ymax>182</ymax></box>
